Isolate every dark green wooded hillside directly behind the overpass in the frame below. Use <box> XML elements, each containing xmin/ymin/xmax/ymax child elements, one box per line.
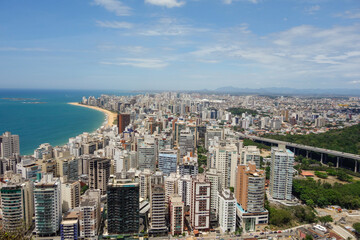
<box><xmin>264</xmin><ymin>124</ymin><xmax>360</xmax><ymax>154</ymax></box>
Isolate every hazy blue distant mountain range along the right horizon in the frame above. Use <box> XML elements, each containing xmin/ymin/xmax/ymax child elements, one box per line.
<box><xmin>214</xmin><ymin>86</ymin><xmax>360</xmax><ymax>96</ymax></box>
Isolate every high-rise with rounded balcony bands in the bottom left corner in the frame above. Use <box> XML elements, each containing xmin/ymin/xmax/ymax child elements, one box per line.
<box><xmin>0</xmin><ymin>174</ymin><xmax>34</xmax><ymax>232</ymax></box>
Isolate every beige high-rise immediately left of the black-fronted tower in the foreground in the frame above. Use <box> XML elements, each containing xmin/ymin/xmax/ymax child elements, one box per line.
<box><xmin>79</xmin><ymin>189</ymin><xmax>101</xmax><ymax>240</ymax></box>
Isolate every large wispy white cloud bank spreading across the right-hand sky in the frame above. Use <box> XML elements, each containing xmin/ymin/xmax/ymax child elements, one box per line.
<box><xmin>188</xmin><ymin>24</ymin><xmax>360</xmax><ymax>87</ymax></box>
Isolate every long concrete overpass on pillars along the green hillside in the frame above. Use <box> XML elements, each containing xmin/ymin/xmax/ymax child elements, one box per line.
<box><xmin>238</xmin><ymin>133</ymin><xmax>360</xmax><ymax>172</ymax></box>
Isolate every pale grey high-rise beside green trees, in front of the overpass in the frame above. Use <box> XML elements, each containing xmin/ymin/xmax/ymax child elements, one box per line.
<box><xmin>270</xmin><ymin>145</ymin><xmax>294</xmax><ymax>200</ymax></box>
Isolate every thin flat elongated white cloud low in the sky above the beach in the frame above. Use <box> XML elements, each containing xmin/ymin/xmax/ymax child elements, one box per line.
<box><xmin>100</xmin><ymin>58</ymin><xmax>168</xmax><ymax>68</ymax></box>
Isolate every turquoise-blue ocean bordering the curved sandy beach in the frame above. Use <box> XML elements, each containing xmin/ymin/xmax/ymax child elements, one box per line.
<box><xmin>0</xmin><ymin>89</ymin><xmax>130</xmax><ymax>155</ymax></box>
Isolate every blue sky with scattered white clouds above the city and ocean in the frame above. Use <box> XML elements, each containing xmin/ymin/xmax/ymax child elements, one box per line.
<box><xmin>0</xmin><ymin>0</ymin><xmax>360</xmax><ymax>90</ymax></box>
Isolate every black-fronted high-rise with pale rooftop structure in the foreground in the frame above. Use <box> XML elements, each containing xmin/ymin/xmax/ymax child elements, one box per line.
<box><xmin>107</xmin><ymin>172</ymin><xmax>139</xmax><ymax>234</ymax></box>
